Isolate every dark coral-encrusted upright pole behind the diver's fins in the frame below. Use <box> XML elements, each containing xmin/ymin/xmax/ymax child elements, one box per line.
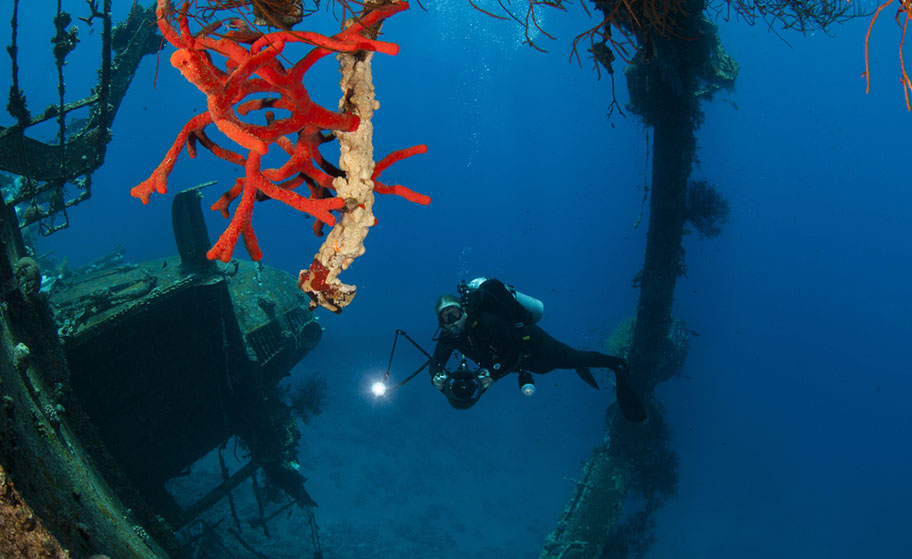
<box><xmin>540</xmin><ymin>0</ymin><xmax>715</xmax><ymax>559</ymax></box>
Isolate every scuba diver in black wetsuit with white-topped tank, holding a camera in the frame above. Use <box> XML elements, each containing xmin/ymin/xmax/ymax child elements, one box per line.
<box><xmin>430</xmin><ymin>277</ymin><xmax>646</xmax><ymax>422</ymax></box>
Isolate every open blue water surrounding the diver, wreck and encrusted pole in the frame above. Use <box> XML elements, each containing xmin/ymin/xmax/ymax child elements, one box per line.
<box><xmin>0</xmin><ymin>0</ymin><xmax>912</xmax><ymax>559</ymax></box>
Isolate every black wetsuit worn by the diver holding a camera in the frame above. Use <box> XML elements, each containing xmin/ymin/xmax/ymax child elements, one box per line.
<box><xmin>430</xmin><ymin>311</ymin><xmax>646</xmax><ymax>421</ymax></box>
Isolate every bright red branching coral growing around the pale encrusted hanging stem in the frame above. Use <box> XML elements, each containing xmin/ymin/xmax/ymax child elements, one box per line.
<box><xmin>130</xmin><ymin>0</ymin><xmax>430</xmax><ymax>261</ymax></box>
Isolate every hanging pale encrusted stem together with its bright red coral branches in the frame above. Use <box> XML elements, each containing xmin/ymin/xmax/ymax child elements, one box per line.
<box><xmin>131</xmin><ymin>0</ymin><xmax>430</xmax><ymax>312</ymax></box>
